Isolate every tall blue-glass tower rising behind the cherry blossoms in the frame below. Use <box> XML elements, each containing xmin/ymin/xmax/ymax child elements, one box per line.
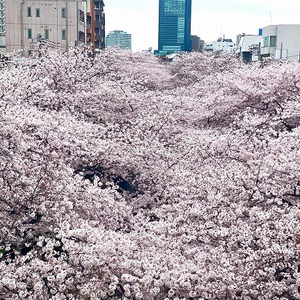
<box><xmin>158</xmin><ymin>0</ymin><xmax>192</xmax><ymax>54</ymax></box>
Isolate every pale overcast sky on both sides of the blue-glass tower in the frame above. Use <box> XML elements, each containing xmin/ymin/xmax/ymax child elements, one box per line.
<box><xmin>104</xmin><ymin>0</ymin><xmax>300</xmax><ymax>51</ymax></box>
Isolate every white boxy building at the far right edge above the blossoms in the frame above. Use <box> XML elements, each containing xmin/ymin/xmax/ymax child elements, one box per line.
<box><xmin>260</xmin><ymin>24</ymin><xmax>300</xmax><ymax>60</ymax></box>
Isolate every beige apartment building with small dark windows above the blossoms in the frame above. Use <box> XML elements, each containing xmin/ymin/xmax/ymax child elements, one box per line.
<box><xmin>5</xmin><ymin>0</ymin><xmax>86</xmax><ymax>57</ymax></box>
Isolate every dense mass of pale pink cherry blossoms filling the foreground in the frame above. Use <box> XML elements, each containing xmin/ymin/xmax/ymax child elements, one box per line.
<box><xmin>0</xmin><ymin>48</ymin><xmax>300</xmax><ymax>300</ymax></box>
